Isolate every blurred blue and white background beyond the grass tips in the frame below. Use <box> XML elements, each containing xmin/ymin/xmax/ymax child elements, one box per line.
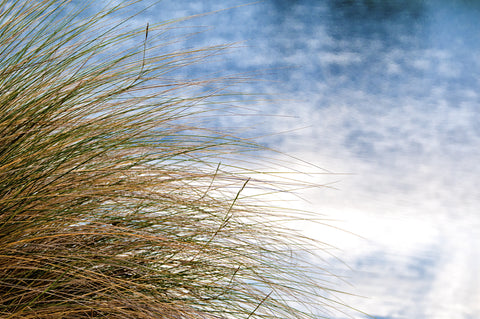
<box><xmin>94</xmin><ymin>0</ymin><xmax>480</xmax><ymax>319</ymax></box>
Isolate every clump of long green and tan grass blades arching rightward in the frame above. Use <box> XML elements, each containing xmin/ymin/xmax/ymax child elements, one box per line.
<box><xmin>0</xmin><ymin>0</ymin><xmax>352</xmax><ymax>318</ymax></box>
